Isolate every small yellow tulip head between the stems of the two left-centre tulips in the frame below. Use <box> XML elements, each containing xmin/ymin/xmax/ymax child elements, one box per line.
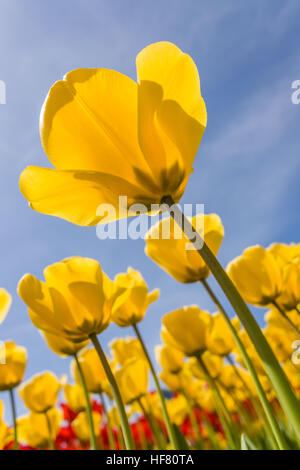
<box><xmin>115</xmin><ymin>359</ymin><xmax>149</xmax><ymax>405</ymax></box>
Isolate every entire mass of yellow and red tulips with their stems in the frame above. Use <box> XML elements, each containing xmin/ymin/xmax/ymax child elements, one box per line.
<box><xmin>0</xmin><ymin>42</ymin><xmax>300</xmax><ymax>450</ymax></box>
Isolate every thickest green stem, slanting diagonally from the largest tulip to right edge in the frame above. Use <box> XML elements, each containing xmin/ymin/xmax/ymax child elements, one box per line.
<box><xmin>161</xmin><ymin>196</ymin><xmax>300</xmax><ymax>443</ymax></box>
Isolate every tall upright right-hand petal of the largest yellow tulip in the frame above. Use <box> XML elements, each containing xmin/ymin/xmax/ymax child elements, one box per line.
<box><xmin>136</xmin><ymin>42</ymin><xmax>207</xmax><ymax>174</ymax></box>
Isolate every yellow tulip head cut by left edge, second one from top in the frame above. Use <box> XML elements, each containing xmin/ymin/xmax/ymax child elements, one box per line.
<box><xmin>0</xmin><ymin>341</ymin><xmax>27</xmax><ymax>391</ymax></box>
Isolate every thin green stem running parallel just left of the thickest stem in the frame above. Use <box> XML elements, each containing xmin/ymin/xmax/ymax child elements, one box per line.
<box><xmin>202</xmin><ymin>279</ymin><xmax>288</xmax><ymax>450</ymax></box>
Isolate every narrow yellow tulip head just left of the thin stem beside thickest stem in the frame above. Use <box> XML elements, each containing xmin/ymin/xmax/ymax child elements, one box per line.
<box><xmin>206</xmin><ymin>313</ymin><xmax>235</xmax><ymax>356</ymax></box>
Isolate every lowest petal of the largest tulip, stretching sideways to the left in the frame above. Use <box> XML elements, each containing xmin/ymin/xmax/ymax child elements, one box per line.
<box><xmin>20</xmin><ymin>166</ymin><xmax>150</xmax><ymax>226</ymax></box>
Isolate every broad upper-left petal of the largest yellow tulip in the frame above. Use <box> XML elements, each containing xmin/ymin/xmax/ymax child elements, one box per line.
<box><xmin>40</xmin><ymin>69</ymin><xmax>146</xmax><ymax>182</ymax></box>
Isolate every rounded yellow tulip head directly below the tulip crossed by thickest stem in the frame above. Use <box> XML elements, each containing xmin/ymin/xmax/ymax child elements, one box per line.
<box><xmin>161</xmin><ymin>305</ymin><xmax>211</xmax><ymax>356</ymax></box>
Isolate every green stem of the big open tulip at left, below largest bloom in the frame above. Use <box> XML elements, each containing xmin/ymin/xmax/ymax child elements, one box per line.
<box><xmin>90</xmin><ymin>333</ymin><xmax>135</xmax><ymax>450</ymax></box>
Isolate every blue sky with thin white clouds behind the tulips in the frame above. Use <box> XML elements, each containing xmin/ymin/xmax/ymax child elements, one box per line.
<box><xmin>0</xmin><ymin>0</ymin><xmax>300</xmax><ymax>421</ymax></box>
